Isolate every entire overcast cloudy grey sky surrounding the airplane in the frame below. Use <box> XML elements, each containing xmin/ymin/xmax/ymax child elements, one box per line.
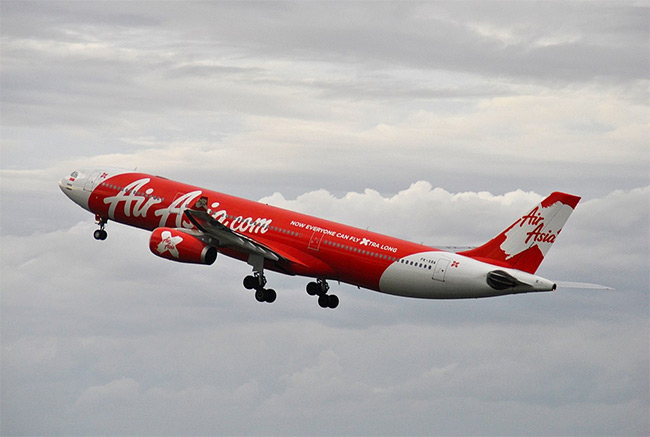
<box><xmin>0</xmin><ymin>1</ymin><xmax>650</xmax><ymax>435</ymax></box>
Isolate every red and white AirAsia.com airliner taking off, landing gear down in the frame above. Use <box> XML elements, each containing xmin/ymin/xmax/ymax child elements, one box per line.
<box><xmin>59</xmin><ymin>168</ymin><xmax>580</xmax><ymax>309</ymax></box>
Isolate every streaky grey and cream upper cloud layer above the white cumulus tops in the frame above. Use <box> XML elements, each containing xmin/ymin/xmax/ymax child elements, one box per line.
<box><xmin>1</xmin><ymin>2</ymin><xmax>648</xmax><ymax>203</ymax></box>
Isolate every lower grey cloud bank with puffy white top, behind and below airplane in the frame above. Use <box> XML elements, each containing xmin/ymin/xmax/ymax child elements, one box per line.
<box><xmin>2</xmin><ymin>182</ymin><xmax>649</xmax><ymax>434</ymax></box>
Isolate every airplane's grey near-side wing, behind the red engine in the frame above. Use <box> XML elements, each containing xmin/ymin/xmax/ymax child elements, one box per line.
<box><xmin>184</xmin><ymin>209</ymin><xmax>288</xmax><ymax>262</ymax></box>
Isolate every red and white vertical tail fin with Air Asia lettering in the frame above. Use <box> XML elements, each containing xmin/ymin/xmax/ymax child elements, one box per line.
<box><xmin>459</xmin><ymin>192</ymin><xmax>580</xmax><ymax>274</ymax></box>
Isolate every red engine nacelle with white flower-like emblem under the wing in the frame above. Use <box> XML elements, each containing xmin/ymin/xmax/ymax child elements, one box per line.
<box><xmin>149</xmin><ymin>228</ymin><xmax>217</xmax><ymax>265</ymax></box>
